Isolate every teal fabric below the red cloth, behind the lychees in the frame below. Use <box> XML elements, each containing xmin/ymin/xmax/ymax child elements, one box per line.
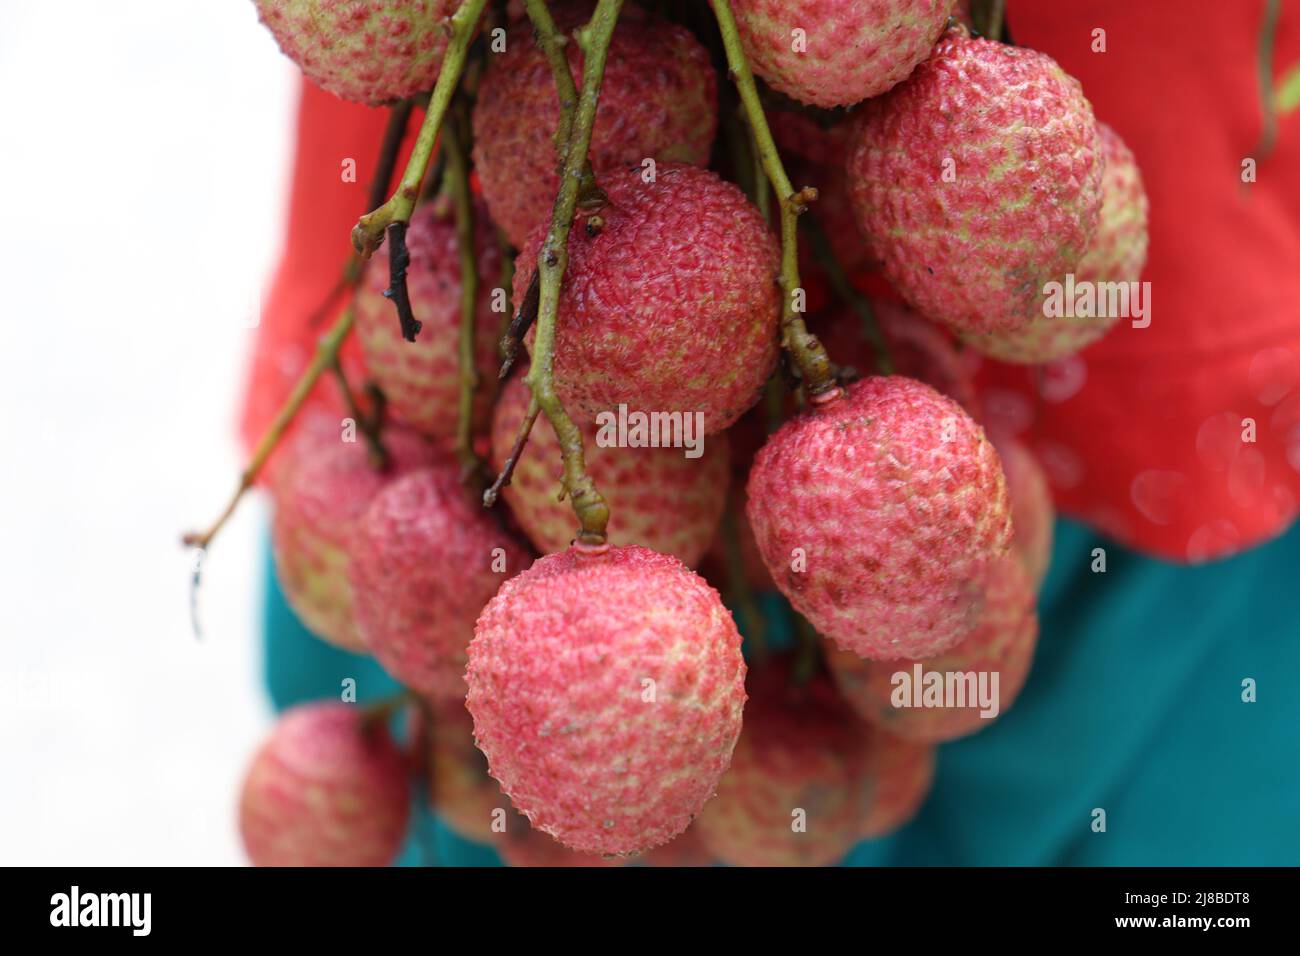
<box><xmin>258</xmin><ymin>520</ymin><xmax>1300</xmax><ymax>866</ymax></box>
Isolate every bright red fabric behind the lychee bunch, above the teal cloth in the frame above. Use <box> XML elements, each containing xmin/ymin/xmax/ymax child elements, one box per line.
<box><xmin>243</xmin><ymin>0</ymin><xmax>1300</xmax><ymax>561</ymax></box>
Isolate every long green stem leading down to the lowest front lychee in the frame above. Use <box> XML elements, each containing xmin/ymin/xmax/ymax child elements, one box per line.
<box><xmin>525</xmin><ymin>0</ymin><xmax>623</xmax><ymax>545</ymax></box>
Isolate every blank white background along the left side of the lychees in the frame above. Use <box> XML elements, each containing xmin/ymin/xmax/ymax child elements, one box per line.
<box><xmin>0</xmin><ymin>0</ymin><xmax>296</xmax><ymax>865</ymax></box>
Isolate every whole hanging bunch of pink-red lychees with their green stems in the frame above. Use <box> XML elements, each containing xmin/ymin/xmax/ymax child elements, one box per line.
<box><xmin>218</xmin><ymin>0</ymin><xmax>1147</xmax><ymax>865</ymax></box>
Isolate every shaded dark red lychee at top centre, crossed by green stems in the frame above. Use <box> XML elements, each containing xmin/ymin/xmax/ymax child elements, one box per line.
<box><xmin>473</xmin><ymin>3</ymin><xmax>718</xmax><ymax>248</ymax></box>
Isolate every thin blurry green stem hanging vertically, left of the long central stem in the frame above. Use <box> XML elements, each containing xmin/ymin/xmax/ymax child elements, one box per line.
<box><xmin>442</xmin><ymin>104</ymin><xmax>482</xmax><ymax>486</ymax></box>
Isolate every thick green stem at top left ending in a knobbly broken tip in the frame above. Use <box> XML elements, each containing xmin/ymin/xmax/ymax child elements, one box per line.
<box><xmin>352</xmin><ymin>0</ymin><xmax>488</xmax><ymax>259</ymax></box>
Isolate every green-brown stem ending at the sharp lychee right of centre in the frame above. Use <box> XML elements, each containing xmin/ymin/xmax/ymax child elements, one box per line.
<box><xmin>710</xmin><ymin>0</ymin><xmax>840</xmax><ymax>401</ymax></box>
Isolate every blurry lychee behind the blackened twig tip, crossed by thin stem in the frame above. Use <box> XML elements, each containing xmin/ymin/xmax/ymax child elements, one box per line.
<box><xmin>356</xmin><ymin>203</ymin><xmax>502</xmax><ymax>438</ymax></box>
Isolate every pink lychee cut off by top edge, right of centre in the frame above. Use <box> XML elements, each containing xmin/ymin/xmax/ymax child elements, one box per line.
<box><xmin>732</xmin><ymin>0</ymin><xmax>953</xmax><ymax>108</ymax></box>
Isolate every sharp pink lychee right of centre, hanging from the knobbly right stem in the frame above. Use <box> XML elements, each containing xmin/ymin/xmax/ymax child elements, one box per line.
<box><xmin>746</xmin><ymin>376</ymin><xmax>1011</xmax><ymax>659</ymax></box>
